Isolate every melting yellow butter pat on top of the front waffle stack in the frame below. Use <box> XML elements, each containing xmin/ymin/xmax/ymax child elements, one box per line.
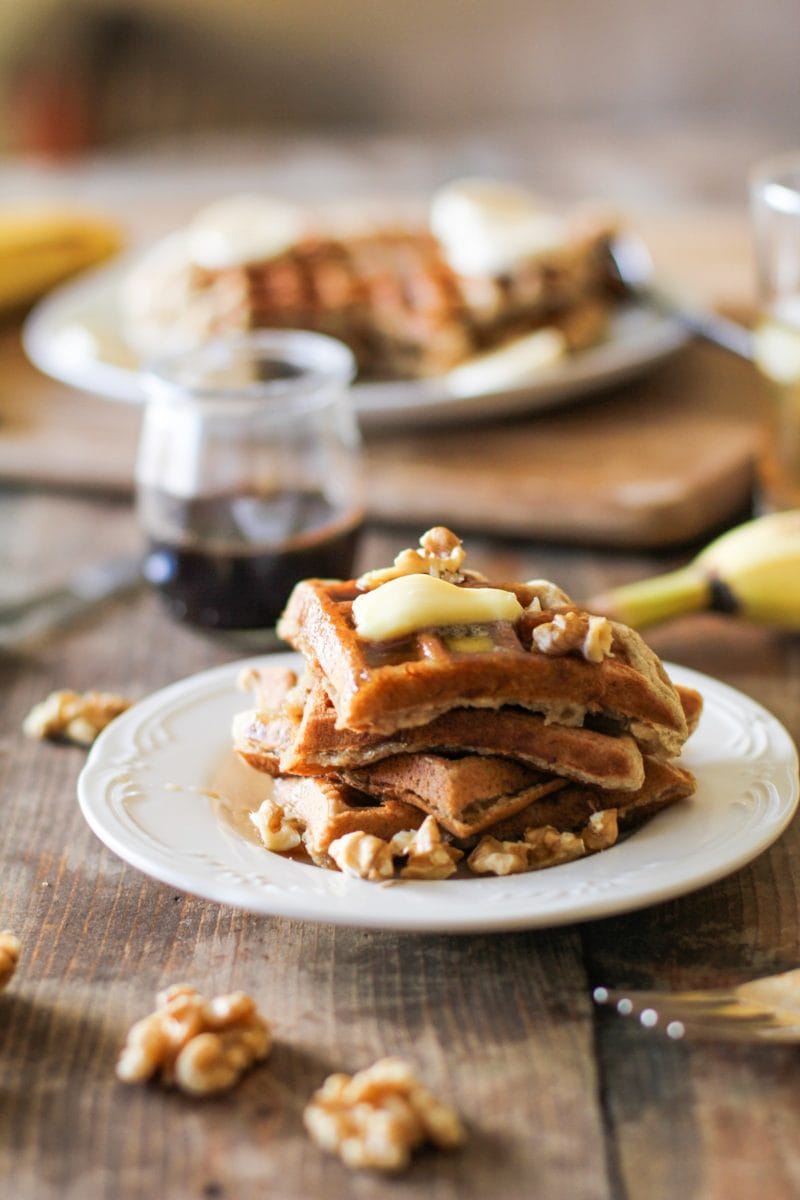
<box><xmin>353</xmin><ymin>575</ymin><xmax>523</xmax><ymax>642</ymax></box>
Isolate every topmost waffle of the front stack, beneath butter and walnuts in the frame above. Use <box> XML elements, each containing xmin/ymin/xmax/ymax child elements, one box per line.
<box><xmin>277</xmin><ymin>580</ymin><xmax>688</xmax><ymax>757</ymax></box>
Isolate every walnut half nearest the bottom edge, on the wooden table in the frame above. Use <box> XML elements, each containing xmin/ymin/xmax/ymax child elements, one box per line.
<box><xmin>303</xmin><ymin>1057</ymin><xmax>465</xmax><ymax>1171</ymax></box>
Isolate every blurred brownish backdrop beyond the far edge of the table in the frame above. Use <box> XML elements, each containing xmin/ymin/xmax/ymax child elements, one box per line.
<box><xmin>0</xmin><ymin>0</ymin><xmax>800</xmax><ymax>157</ymax></box>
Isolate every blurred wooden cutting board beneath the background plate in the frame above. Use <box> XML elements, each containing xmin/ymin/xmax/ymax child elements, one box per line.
<box><xmin>0</xmin><ymin>332</ymin><xmax>763</xmax><ymax>548</ymax></box>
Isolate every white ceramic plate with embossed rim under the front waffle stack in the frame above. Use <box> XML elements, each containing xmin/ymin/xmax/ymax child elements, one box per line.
<box><xmin>78</xmin><ymin>655</ymin><xmax>798</xmax><ymax>932</ymax></box>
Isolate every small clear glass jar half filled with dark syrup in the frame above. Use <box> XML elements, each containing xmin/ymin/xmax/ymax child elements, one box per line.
<box><xmin>136</xmin><ymin>330</ymin><xmax>363</xmax><ymax>630</ymax></box>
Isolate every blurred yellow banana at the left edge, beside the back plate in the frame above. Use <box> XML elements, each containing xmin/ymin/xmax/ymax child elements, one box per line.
<box><xmin>0</xmin><ymin>208</ymin><xmax>122</xmax><ymax>317</ymax></box>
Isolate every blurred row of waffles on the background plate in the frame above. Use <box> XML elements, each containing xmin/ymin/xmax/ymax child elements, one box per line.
<box><xmin>122</xmin><ymin>190</ymin><xmax>618</xmax><ymax>379</ymax></box>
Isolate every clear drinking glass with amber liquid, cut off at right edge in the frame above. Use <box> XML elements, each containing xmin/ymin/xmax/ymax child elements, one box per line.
<box><xmin>750</xmin><ymin>151</ymin><xmax>800</xmax><ymax>511</ymax></box>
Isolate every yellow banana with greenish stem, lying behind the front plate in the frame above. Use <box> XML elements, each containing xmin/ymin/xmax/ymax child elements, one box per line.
<box><xmin>587</xmin><ymin>509</ymin><xmax>800</xmax><ymax>630</ymax></box>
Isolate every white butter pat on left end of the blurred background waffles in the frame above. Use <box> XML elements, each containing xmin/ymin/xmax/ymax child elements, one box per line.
<box><xmin>188</xmin><ymin>193</ymin><xmax>306</xmax><ymax>270</ymax></box>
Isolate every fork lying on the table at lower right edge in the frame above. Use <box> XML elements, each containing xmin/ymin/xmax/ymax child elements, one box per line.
<box><xmin>593</xmin><ymin>968</ymin><xmax>800</xmax><ymax>1043</ymax></box>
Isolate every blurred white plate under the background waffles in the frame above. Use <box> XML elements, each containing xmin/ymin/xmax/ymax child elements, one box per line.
<box><xmin>23</xmin><ymin>258</ymin><xmax>686</xmax><ymax>428</ymax></box>
